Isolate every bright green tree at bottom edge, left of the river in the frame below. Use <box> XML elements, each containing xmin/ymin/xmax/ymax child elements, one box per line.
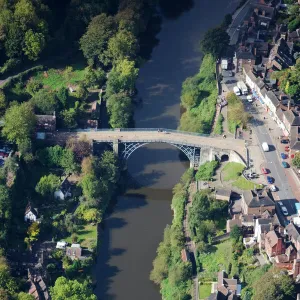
<box><xmin>50</xmin><ymin>277</ymin><xmax>97</xmax><ymax>300</ymax></box>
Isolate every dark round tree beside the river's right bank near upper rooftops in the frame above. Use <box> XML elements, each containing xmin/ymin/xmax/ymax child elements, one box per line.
<box><xmin>200</xmin><ymin>27</ymin><xmax>230</xmax><ymax>58</ymax></box>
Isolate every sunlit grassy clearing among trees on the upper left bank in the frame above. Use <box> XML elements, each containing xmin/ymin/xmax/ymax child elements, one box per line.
<box><xmin>34</xmin><ymin>65</ymin><xmax>84</xmax><ymax>90</ymax></box>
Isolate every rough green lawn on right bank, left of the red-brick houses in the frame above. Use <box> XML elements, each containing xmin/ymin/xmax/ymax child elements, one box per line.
<box><xmin>199</xmin><ymin>240</ymin><xmax>232</xmax><ymax>281</ymax></box>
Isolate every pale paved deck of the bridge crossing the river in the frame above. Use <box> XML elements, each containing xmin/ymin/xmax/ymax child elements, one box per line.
<box><xmin>54</xmin><ymin>129</ymin><xmax>245</xmax><ymax>157</ymax></box>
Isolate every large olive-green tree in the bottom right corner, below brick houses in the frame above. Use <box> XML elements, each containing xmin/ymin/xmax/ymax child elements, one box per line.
<box><xmin>253</xmin><ymin>268</ymin><xmax>295</xmax><ymax>300</ymax></box>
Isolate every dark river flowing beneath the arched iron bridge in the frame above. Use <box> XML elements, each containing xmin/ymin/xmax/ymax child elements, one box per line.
<box><xmin>96</xmin><ymin>0</ymin><xmax>239</xmax><ymax>300</ymax></box>
